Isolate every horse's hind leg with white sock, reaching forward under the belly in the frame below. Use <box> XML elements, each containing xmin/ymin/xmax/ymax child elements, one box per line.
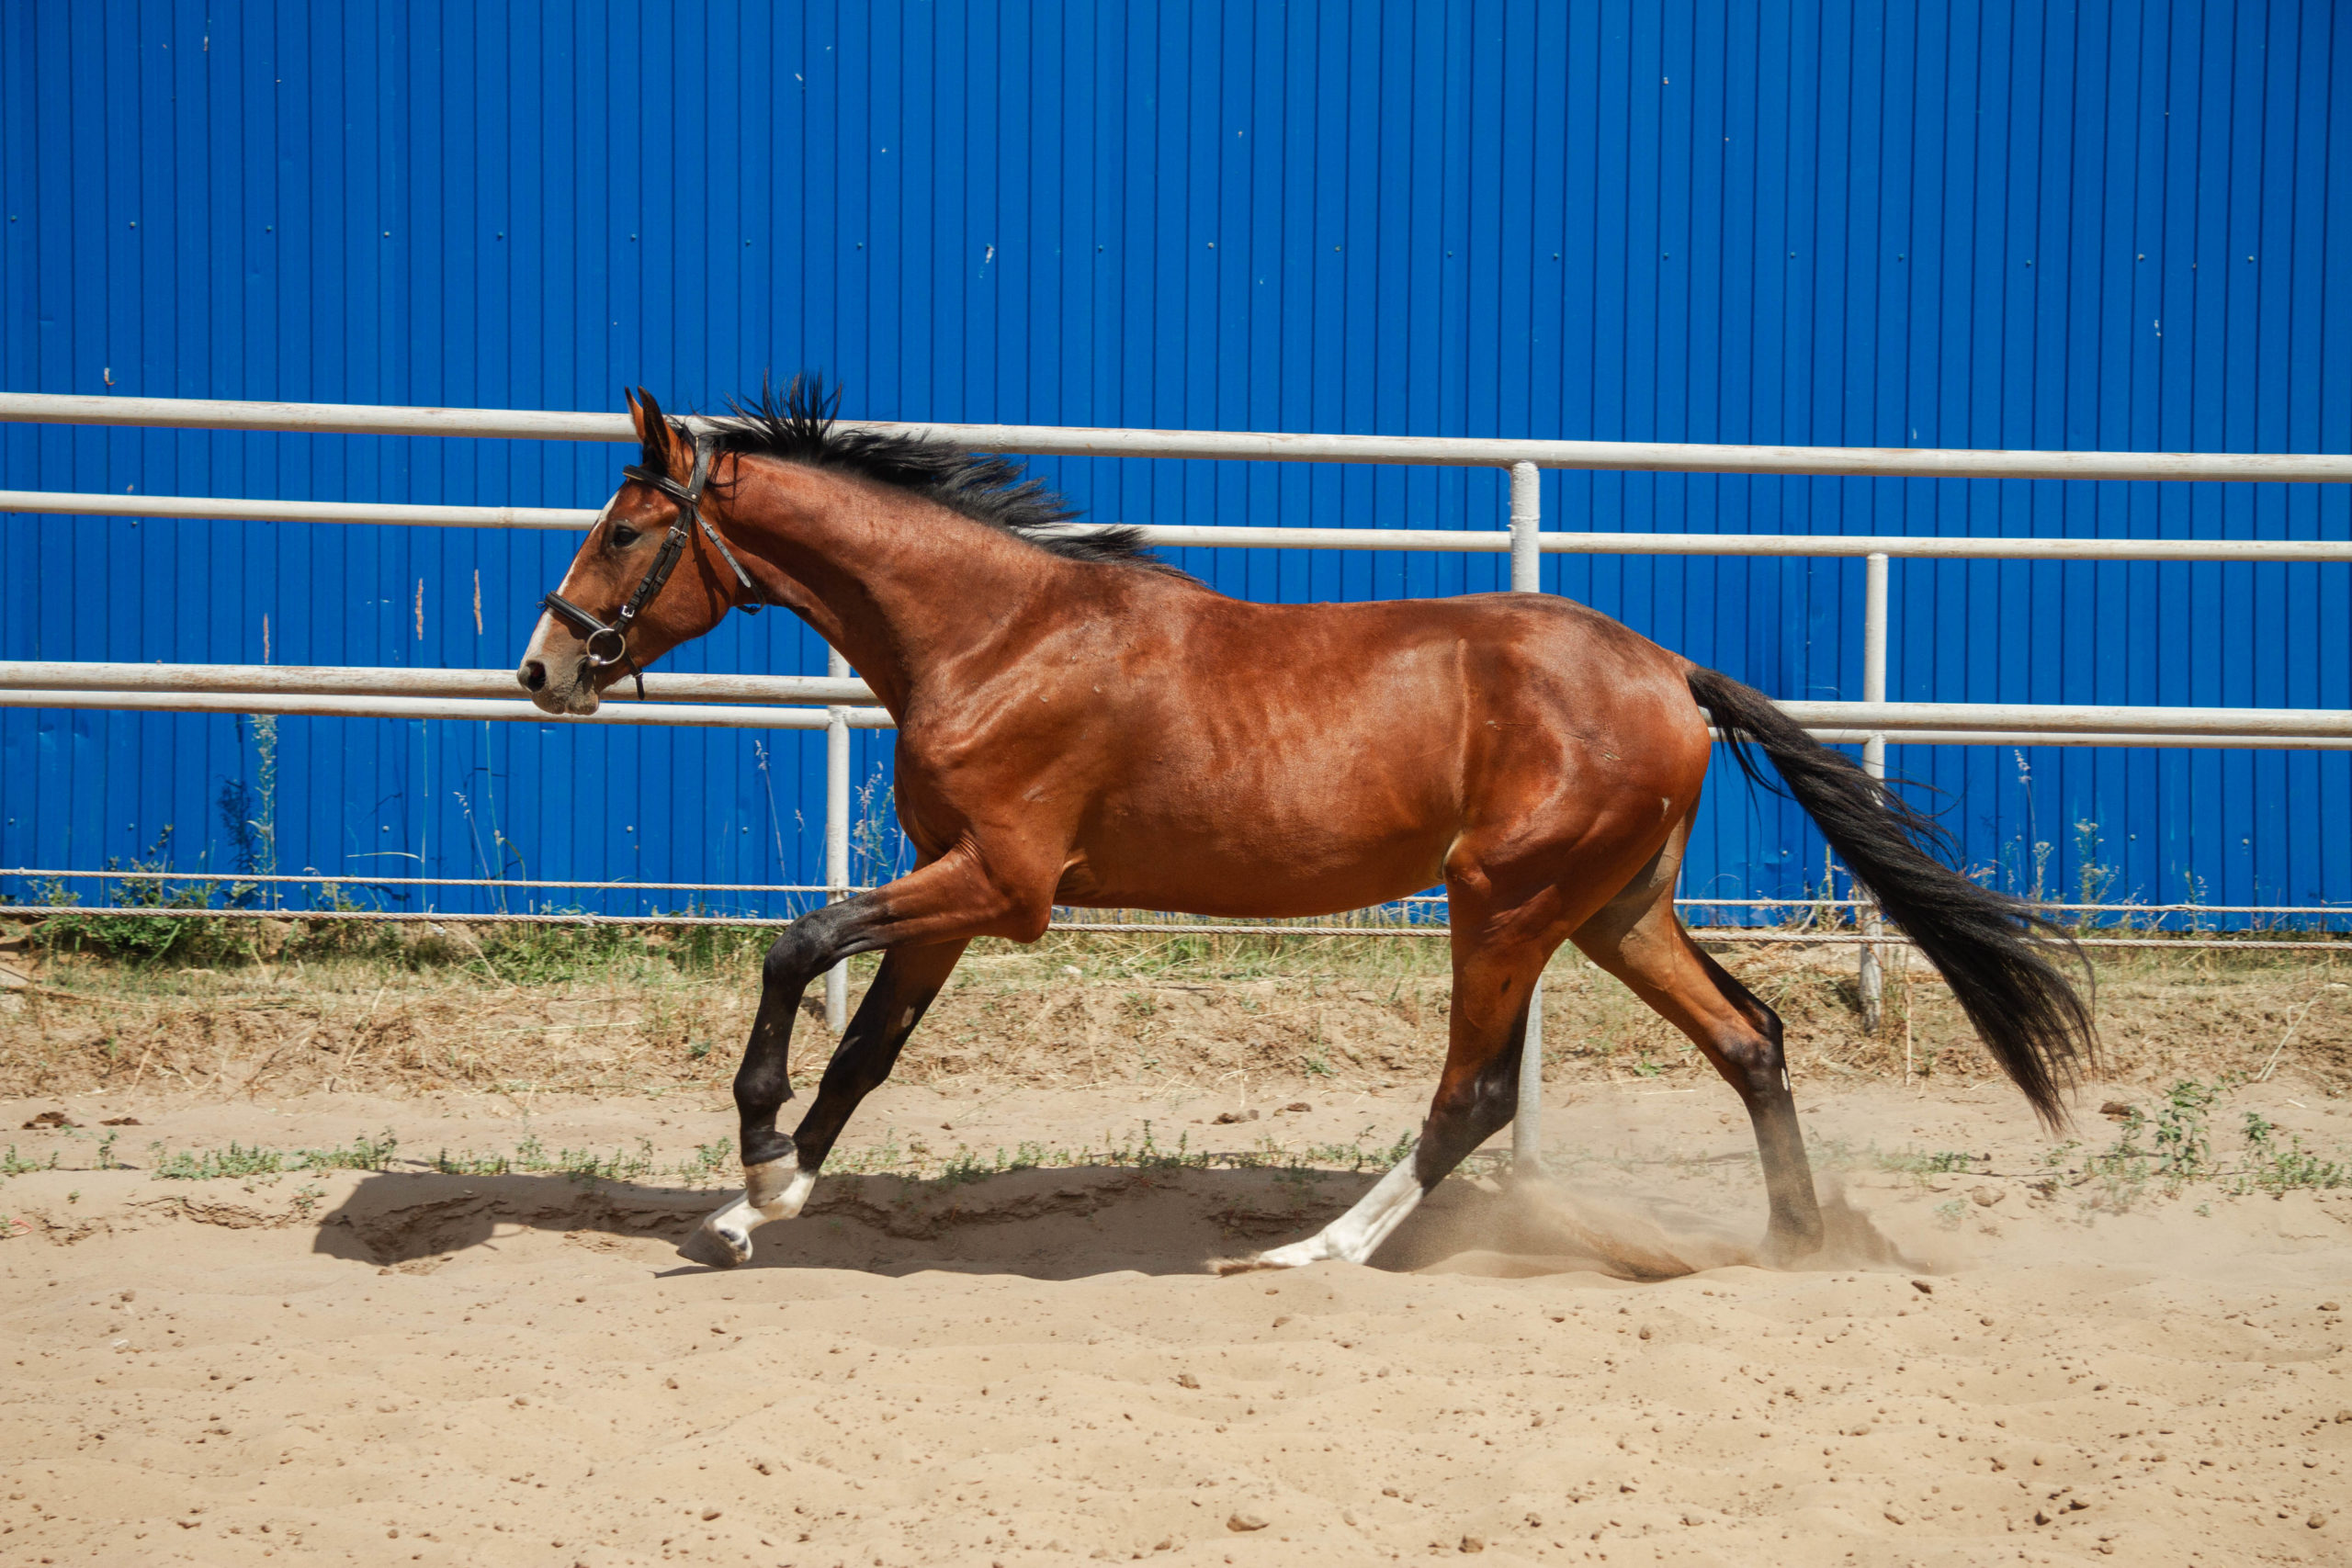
<box><xmin>1218</xmin><ymin>936</ymin><xmax>1553</xmax><ymax>1274</ymax></box>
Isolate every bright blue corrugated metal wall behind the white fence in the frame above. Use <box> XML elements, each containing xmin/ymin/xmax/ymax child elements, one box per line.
<box><xmin>0</xmin><ymin>0</ymin><xmax>2352</xmax><ymax>926</ymax></box>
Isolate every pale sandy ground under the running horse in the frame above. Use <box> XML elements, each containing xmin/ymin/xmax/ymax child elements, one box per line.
<box><xmin>0</xmin><ymin>1081</ymin><xmax>2352</xmax><ymax>1568</ymax></box>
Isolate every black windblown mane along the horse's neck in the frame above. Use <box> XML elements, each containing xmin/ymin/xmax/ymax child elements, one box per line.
<box><xmin>644</xmin><ymin>376</ymin><xmax>1185</xmax><ymax>576</ymax></box>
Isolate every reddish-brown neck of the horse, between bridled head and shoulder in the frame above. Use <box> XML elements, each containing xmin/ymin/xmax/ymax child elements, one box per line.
<box><xmin>727</xmin><ymin>461</ymin><xmax>1070</xmax><ymax>712</ymax></box>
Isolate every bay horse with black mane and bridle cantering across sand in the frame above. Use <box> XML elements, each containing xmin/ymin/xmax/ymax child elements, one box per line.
<box><xmin>517</xmin><ymin>378</ymin><xmax>2096</xmax><ymax>1267</ymax></box>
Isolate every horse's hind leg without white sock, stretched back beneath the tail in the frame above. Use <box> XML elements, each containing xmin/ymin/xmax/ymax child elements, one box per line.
<box><xmin>1574</xmin><ymin>888</ymin><xmax>1823</xmax><ymax>1262</ymax></box>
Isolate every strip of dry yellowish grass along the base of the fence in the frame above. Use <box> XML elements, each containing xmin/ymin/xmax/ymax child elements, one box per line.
<box><xmin>0</xmin><ymin>907</ymin><xmax>2352</xmax><ymax>1096</ymax></box>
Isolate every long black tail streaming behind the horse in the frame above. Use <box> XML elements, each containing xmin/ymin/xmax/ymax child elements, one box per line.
<box><xmin>1689</xmin><ymin>665</ymin><xmax>2096</xmax><ymax>1128</ymax></box>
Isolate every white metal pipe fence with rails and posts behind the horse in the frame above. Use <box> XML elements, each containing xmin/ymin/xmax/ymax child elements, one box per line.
<box><xmin>0</xmin><ymin>392</ymin><xmax>2352</xmax><ymax>1086</ymax></box>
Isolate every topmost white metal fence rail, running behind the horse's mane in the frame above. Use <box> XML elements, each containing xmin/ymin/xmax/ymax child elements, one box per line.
<box><xmin>0</xmin><ymin>392</ymin><xmax>2352</xmax><ymax>484</ymax></box>
